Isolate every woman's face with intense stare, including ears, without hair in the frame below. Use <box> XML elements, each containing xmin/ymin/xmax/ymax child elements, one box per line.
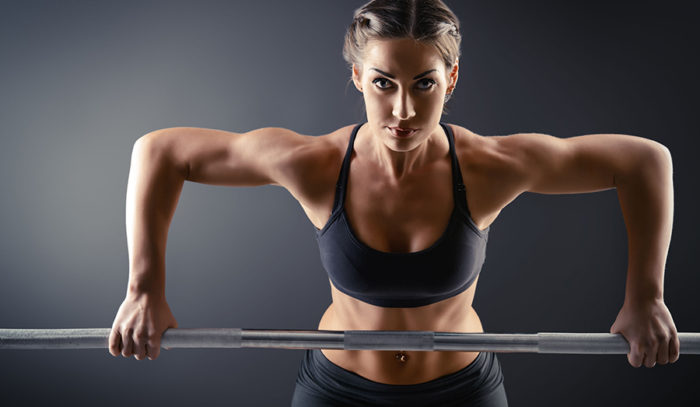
<box><xmin>353</xmin><ymin>38</ymin><xmax>458</xmax><ymax>151</ymax></box>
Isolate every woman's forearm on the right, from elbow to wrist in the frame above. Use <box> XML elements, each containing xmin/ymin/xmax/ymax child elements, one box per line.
<box><xmin>615</xmin><ymin>145</ymin><xmax>673</xmax><ymax>301</ymax></box>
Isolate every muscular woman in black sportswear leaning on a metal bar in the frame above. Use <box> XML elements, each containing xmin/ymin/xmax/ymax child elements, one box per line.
<box><xmin>109</xmin><ymin>0</ymin><xmax>679</xmax><ymax>406</ymax></box>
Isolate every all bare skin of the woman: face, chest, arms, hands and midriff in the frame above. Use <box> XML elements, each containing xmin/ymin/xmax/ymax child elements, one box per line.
<box><xmin>109</xmin><ymin>39</ymin><xmax>679</xmax><ymax>384</ymax></box>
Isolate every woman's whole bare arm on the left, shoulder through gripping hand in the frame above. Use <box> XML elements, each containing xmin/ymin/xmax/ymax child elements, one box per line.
<box><xmin>109</xmin><ymin>127</ymin><xmax>312</xmax><ymax>360</ymax></box>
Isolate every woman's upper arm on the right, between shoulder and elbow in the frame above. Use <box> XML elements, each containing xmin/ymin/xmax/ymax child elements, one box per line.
<box><xmin>505</xmin><ymin>133</ymin><xmax>668</xmax><ymax>194</ymax></box>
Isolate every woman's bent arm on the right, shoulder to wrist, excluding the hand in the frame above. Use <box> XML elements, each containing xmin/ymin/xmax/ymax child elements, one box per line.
<box><xmin>498</xmin><ymin>134</ymin><xmax>673</xmax><ymax>299</ymax></box>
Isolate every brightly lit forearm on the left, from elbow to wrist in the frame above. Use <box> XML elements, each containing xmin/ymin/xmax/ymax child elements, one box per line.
<box><xmin>126</xmin><ymin>133</ymin><xmax>186</xmax><ymax>295</ymax></box>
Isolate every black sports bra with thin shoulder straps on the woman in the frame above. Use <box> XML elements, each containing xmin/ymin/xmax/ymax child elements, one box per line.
<box><xmin>315</xmin><ymin>122</ymin><xmax>490</xmax><ymax>307</ymax></box>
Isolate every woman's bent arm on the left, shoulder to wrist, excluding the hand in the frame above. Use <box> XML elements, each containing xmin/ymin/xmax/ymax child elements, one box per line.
<box><xmin>126</xmin><ymin>127</ymin><xmax>322</xmax><ymax>292</ymax></box>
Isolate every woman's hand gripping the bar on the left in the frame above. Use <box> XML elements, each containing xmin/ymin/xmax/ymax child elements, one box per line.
<box><xmin>109</xmin><ymin>293</ymin><xmax>177</xmax><ymax>360</ymax></box>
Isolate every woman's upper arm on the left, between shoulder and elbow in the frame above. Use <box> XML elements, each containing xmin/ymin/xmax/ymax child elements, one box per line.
<box><xmin>144</xmin><ymin>127</ymin><xmax>303</xmax><ymax>186</ymax></box>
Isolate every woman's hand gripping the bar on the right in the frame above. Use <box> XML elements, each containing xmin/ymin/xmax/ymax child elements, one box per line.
<box><xmin>610</xmin><ymin>299</ymin><xmax>680</xmax><ymax>367</ymax></box>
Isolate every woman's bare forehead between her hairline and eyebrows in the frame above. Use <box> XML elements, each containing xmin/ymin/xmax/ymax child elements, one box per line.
<box><xmin>363</xmin><ymin>38</ymin><xmax>444</xmax><ymax>75</ymax></box>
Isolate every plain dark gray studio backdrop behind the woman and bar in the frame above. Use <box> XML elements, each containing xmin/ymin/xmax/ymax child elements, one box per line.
<box><xmin>0</xmin><ymin>0</ymin><xmax>700</xmax><ymax>406</ymax></box>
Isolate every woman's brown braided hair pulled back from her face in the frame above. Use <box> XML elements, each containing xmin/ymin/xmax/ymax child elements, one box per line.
<box><xmin>343</xmin><ymin>0</ymin><xmax>462</xmax><ymax>112</ymax></box>
